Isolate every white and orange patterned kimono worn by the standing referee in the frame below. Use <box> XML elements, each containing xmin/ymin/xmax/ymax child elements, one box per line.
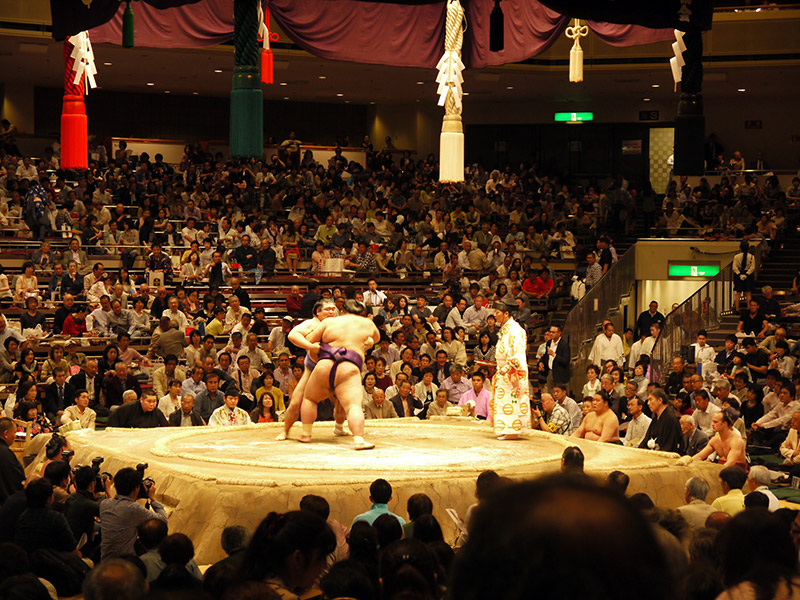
<box><xmin>490</xmin><ymin>318</ymin><xmax>530</xmax><ymax>435</ymax></box>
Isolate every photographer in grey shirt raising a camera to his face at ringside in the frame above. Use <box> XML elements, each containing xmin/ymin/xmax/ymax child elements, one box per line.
<box><xmin>100</xmin><ymin>467</ymin><xmax>167</xmax><ymax>560</ymax></box>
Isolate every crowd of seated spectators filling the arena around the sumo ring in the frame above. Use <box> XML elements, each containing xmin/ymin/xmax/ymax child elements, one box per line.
<box><xmin>0</xmin><ymin>134</ymin><xmax>800</xmax><ymax>598</ymax></box>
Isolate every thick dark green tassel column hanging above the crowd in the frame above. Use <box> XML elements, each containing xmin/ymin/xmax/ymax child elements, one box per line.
<box><xmin>231</xmin><ymin>0</ymin><xmax>264</xmax><ymax>158</ymax></box>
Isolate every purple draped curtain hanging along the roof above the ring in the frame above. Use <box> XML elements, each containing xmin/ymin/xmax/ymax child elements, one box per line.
<box><xmin>91</xmin><ymin>0</ymin><xmax>672</xmax><ymax>69</ymax></box>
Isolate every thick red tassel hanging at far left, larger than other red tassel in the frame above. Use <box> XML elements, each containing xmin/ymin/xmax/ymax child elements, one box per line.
<box><xmin>61</xmin><ymin>38</ymin><xmax>89</xmax><ymax>169</ymax></box>
